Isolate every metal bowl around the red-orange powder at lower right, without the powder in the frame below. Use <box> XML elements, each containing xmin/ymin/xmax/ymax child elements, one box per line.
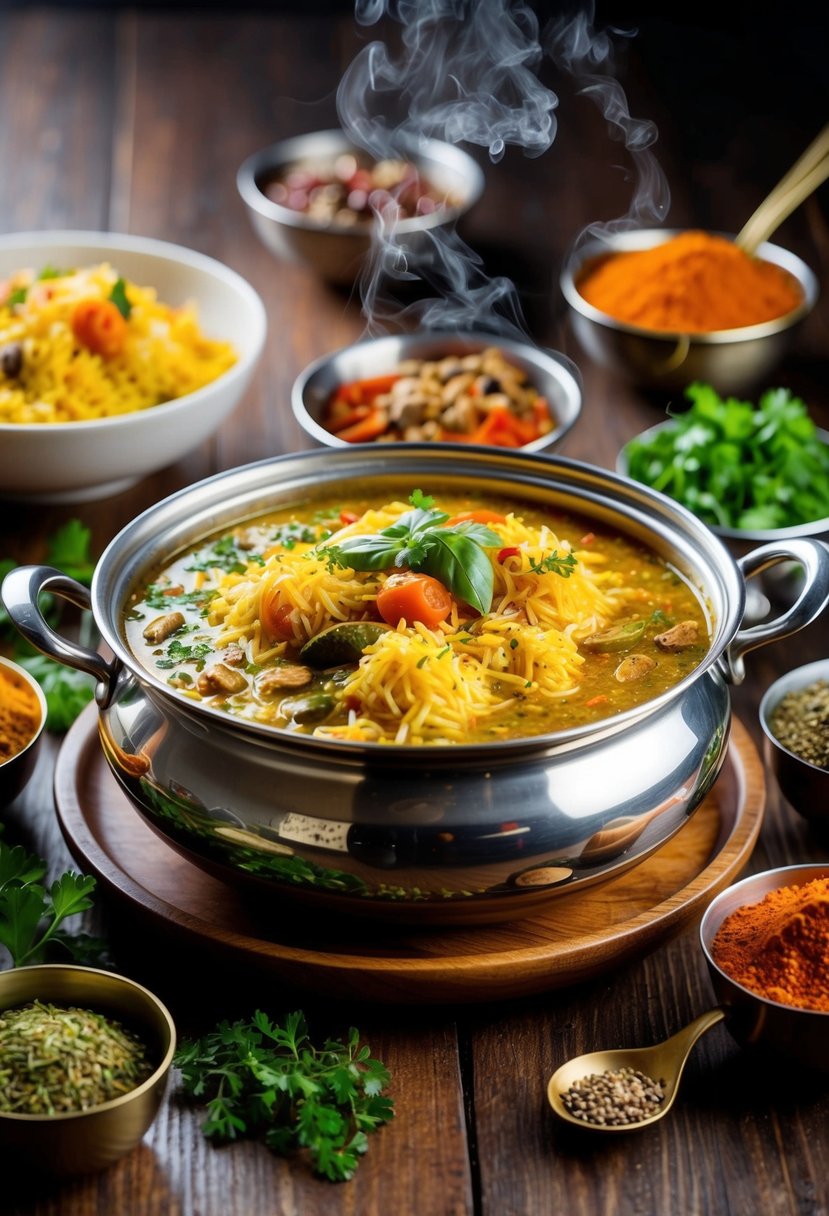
<box><xmin>699</xmin><ymin>866</ymin><xmax>829</xmax><ymax>1071</ymax></box>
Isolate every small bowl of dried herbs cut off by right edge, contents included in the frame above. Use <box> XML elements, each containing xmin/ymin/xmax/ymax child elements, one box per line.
<box><xmin>760</xmin><ymin>659</ymin><xmax>829</xmax><ymax>829</ymax></box>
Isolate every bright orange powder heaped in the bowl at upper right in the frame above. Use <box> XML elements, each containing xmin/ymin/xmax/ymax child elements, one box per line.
<box><xmin>576</xmin><ymin>231</ymin><xmax>803</xmax><ymax>333</ymax></box>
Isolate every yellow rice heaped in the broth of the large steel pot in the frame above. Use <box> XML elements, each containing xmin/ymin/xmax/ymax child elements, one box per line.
<box><xmin>208</xmin><ymin>502</ymin><xmax>632</xmax><ymax>743</ymax></box>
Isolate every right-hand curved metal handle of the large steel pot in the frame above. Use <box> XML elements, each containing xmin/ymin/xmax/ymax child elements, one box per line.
<box><xmin>720</xmin><ymin>537</ymin><xmax>829</xmax><ymax>685</ymax></box>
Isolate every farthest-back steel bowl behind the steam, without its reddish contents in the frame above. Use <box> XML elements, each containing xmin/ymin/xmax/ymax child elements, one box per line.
<box><xmin>236</xmin><ymin>130</ymin><xmax>484</xmax><ymax>286</ymax></box>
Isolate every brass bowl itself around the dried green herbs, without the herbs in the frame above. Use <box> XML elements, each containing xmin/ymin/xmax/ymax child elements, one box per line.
<box><xmin>0</xmin><ymin>964</ymin><xmax>176</xmax><ymax>1177</ymax></box>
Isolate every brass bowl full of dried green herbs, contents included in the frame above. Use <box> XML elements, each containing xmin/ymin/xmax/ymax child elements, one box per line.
<box><xmin>0</xmin><ymin>964</ymin><xmax>176</xmax><ymax>1176</ymax></box>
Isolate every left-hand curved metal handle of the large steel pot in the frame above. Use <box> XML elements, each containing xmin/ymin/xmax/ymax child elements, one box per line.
<box><xmin>0</xmin><ymin>565</ymin><xmax>120</xmax><ymax>706</ymax></box>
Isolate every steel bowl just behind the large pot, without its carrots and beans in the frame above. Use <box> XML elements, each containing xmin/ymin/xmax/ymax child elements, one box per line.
<box><xmin>291</xmin><ymin>332</ymin><xmax>582</xmax><ymax>451</ymax></box>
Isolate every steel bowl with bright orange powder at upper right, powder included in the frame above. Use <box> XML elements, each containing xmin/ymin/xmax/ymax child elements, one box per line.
<box><xmin>559</xmin><ymin>229</ymin><xmax>818</xmax><ymax>393</ymax></box>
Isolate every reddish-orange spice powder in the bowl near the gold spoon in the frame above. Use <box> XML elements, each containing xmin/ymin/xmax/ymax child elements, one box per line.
<box><xmin>711</xmin><ymin>878</ymin><xmax>829</xmax><ymax>1013</ymax></box>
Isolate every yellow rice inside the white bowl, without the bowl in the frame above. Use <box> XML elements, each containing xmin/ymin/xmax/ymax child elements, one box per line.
<box><xmin>0</xmin><ymin>263</ymin><xmax>237</xmax><ymax>424</ymax></box>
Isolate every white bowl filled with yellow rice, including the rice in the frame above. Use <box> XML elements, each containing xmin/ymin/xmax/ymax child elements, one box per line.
<box><xmin>0</xmin><ymin>231</ymin><xmax>266</xmax><ymax>502</ymax></box>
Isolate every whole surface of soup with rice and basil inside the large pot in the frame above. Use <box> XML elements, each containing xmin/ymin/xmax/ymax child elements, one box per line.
<box><xmin>125</xmin><ymin>486</ymin><xmax>710</xmax><ymax>745</ymax></box>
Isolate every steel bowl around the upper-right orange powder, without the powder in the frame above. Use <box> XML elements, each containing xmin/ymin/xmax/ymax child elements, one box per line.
<box><xmin>560</xmin><ymin>229</ymin><xmax>818</xmax><ymax>393</ymax></box>
